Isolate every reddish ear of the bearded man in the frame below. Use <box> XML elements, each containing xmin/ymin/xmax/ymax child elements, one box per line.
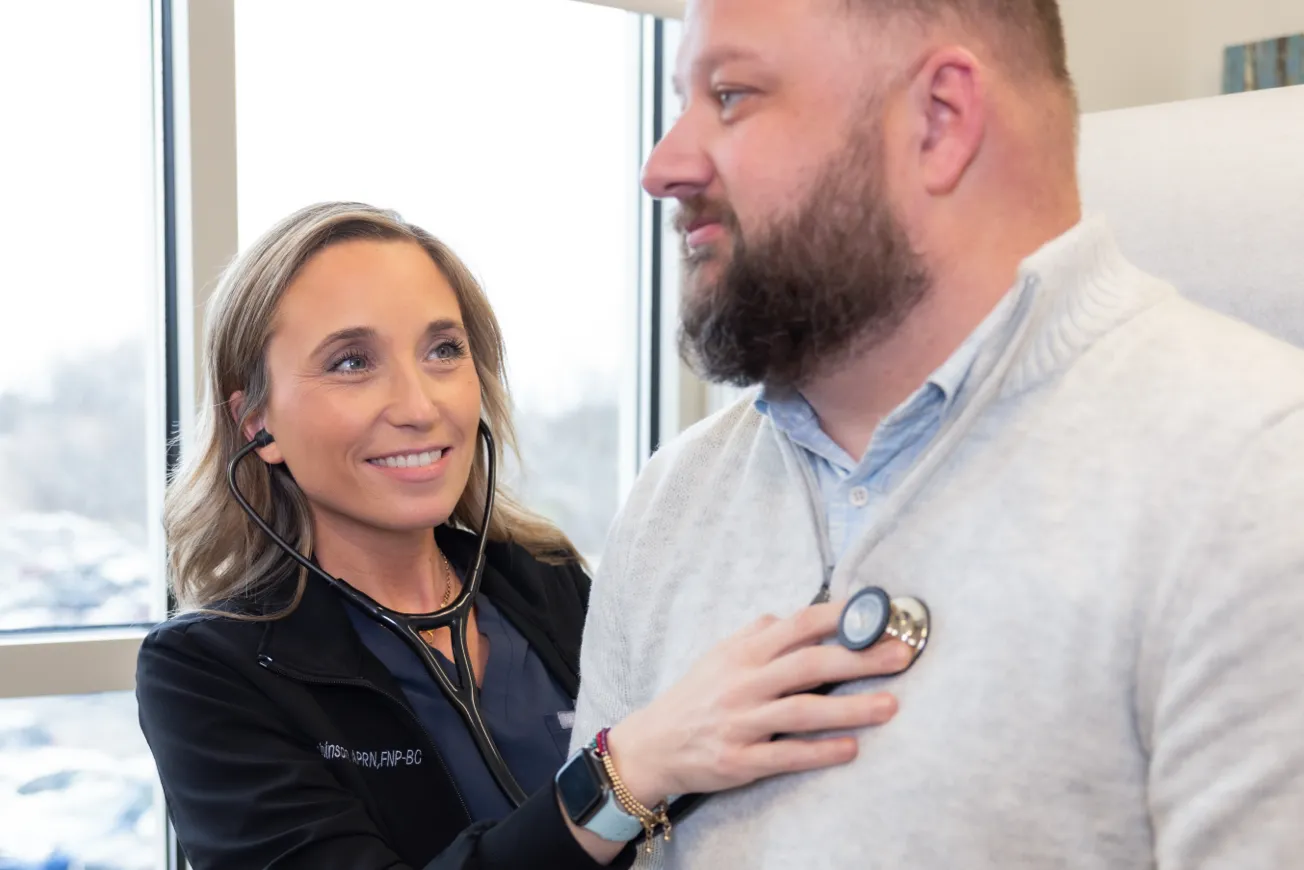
<box><xmin>911</xmin><ymin>46</ymin><xmax>987</xmax><ymax>196</ymax></box>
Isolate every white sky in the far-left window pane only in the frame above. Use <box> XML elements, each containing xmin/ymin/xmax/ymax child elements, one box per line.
<box><xmin>0</xmin><ymin>0</ymin><xmax>162</xmax><ymax>393</ymax></box>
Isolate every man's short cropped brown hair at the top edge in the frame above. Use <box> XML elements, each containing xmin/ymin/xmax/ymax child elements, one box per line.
<box><xmin>850</xmin><ymin>0</ymin><xmax>1073</xmax><ymax>94</ymax></box>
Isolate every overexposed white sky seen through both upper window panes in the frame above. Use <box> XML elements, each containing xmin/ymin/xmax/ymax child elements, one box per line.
<box><xmin>0</xmin><ymin>0</ymin><xmax>638</xmax><ymax>410</ymax></box>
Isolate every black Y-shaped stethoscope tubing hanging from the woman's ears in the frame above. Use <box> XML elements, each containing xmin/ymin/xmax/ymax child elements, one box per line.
<box><xmin>227</xmin><ymin>421</ymin><xmax>526</xmax><ymax>806</ymax></box>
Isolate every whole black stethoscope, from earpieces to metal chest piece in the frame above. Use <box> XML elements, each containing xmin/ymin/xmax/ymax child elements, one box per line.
<box><xmin>227</xmin><ymin>421</ymin><xmax>930</xmax><ymax>820</ymax></box>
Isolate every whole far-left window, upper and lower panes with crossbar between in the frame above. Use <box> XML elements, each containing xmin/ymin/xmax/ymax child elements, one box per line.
<box><xmin>0</xmin><ymin>0</ymin><xmax>166</xmax><ymax>870</ymax></box>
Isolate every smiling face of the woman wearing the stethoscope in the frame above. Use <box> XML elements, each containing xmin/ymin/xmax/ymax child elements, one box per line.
<box><xmin>248</xmin><ymin>240</ymin><xmax>480</xmax><ymax>532</ymax></box>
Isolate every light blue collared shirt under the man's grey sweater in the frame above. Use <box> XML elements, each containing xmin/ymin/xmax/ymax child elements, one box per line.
<box><xmin>756</xmin><ymin>293</ymin><xmax>1015</xmax><ymax>560</ymax></box>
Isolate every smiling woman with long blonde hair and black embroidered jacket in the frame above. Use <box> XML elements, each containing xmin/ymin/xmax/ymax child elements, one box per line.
<box><xmin>137</xmin><ymin>203</ymin><xmax>901</xmax><ymax>870</ymax></box>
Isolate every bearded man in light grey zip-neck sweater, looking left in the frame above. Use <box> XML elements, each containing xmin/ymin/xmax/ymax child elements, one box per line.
<box><xmin>575</xmin><ymin>0</ymin><xmax>1304</xmax><ymax>870</ymax></box>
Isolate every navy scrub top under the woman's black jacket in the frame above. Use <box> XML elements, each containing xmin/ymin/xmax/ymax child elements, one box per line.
<box><xmin>346</xmin><ymin>595</ymin><xmax>575</xmax><ymax>822</ymax></box>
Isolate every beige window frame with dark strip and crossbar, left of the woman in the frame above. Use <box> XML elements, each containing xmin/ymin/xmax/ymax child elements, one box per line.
<box><xmin>0</xmin><ymin>0</ymin><xmax>236</xmax><ymax>869</ymax></box>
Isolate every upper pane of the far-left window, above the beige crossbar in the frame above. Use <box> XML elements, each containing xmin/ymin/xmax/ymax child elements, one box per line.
<box><xmin>0</xmin><ymin>1</ymin><xmax>164</xmax><ymax>630</ymax></box>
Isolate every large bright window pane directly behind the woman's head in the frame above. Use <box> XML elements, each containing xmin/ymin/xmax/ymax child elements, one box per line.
<box><xmin>236</xmin><ymin>0</ymin><xmax>640</xmax><ymax>561</ymax></box>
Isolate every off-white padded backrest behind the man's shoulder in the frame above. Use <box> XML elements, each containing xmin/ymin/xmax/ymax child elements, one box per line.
<box><xmin>1078</xmin><ymin>86</ymin><xmax>1304</xmax><ymax>346</ymax></box>
